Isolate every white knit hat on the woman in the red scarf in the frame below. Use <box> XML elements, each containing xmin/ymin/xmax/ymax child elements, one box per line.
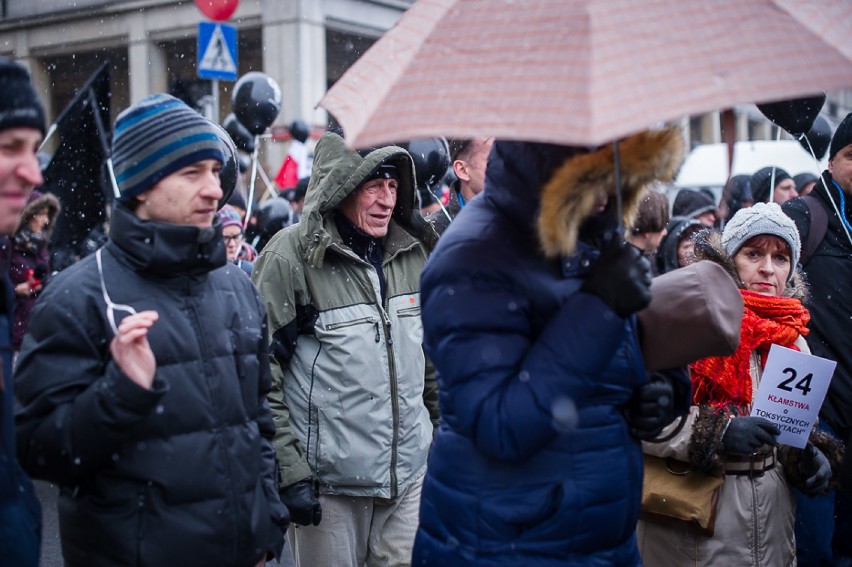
<box><xmin>722</xmin><ymin>203</ymin><xmax>802</xmax><ymax>283</ymax></box>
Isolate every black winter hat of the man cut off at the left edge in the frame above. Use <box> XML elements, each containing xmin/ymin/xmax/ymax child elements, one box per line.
<box><xmin>0</xmin><ymin>57</ymin><xmax>45</xmax><ymax>136</ymax></box>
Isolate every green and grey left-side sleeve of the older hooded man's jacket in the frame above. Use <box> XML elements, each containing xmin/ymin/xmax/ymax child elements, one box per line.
<box><xmin>252</xmin><ymin>245</ymin><xmax>311</xmax><ymax>488</ymax></box>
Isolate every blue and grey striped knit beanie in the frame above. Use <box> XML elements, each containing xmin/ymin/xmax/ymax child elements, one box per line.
<box><xmin>112</xmin><ymin>94</ymin><xmax>225</xmax><ymax>203</ymax></box>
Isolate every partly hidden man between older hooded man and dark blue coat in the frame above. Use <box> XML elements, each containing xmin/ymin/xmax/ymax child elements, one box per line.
<box><xmin>426</xmin><ymin>138</ymin><xmax>494</xmax><ymax>235</ymax></box>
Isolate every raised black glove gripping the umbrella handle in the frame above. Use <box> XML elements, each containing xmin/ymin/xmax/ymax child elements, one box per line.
<box><xmin>580</xmin><ymin>242</ymin><xmax>651</xmax><ymax>318</ymax></box>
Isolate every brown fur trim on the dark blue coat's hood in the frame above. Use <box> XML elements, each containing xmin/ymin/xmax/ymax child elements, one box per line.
<box><xmin>538</xmin><ymin>128</ymin><xmax>684</xmax><ymax>257</ymax></box>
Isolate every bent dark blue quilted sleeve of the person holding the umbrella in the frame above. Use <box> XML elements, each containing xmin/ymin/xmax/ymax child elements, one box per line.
<box><xmin>422</xmin><ymin>249</ymin><xmax>628</xmax><ymax>461</ymax></box>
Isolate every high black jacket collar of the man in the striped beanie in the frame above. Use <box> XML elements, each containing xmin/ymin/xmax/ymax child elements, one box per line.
<box><xmin>109</xmin><ymin>204</ymin><xmax>227</xmax><ymax>277</ymax></box>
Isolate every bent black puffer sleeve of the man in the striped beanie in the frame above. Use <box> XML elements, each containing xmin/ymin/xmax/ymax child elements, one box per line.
<box><xmin>15</xmin><ymin>280</ymin><xmax>168</xmax><ymax>485</ymax></box>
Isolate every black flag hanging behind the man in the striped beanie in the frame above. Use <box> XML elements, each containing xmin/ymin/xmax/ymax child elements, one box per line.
<box><xmin>41</xmin><ymin>61</ymin><xmax>113</xmax><ymax>270</ymax></box>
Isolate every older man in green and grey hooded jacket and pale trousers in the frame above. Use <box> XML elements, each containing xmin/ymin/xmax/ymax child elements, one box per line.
<box><xmin>252</xmin><ymin>131</ymin><xmax>438</xmax><ymax>567</ymax></box>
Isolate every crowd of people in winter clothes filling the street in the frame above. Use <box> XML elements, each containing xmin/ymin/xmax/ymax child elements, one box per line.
<box><xmin>0</xmin><ymin>54</ymin><xmax>852</xmax><ymax>567</ymax></box>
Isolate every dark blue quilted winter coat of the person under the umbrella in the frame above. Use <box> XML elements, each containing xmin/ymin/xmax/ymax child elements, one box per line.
<box><xmin>413</xmin><ymin>141</ymin><xmax>646</xmax><ymax>567</ymax></box>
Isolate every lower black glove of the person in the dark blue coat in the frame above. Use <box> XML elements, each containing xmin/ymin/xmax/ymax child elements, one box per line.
<box><xmin>624</xmin><ymin>372</ymin><xmax>675</xmax><ymax>440</ymax></box>
